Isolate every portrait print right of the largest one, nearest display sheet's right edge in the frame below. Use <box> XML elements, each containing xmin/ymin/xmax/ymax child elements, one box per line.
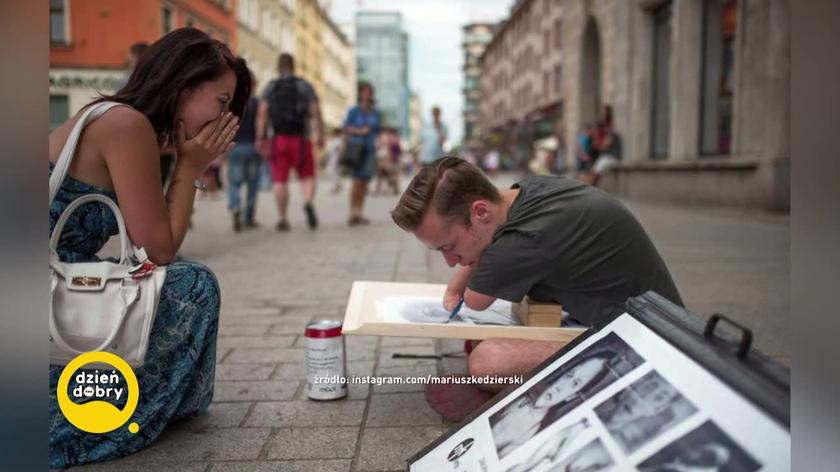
<box><xmin>595</xmin><ymin>371</ymin><xmax>697</xmax><ymax>454</ymax></box>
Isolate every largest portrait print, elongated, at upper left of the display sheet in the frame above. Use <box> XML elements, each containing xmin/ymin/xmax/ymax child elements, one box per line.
<box><xmin>489</xmin><ymin>333</ymin><xmax>644</xmax><ymax>459</ymax></box>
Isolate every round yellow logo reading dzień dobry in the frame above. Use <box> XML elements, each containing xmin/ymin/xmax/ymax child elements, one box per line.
<box><xmin>57</xmin><ymin>351</ymin><xmax>140</xmax><ymax>433</ymax></box>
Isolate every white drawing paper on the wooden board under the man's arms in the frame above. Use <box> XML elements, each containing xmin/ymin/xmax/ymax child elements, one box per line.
<box><xmin>379</xmin><ymin>296</ymin><xmax>522</xmax><ymax>326</ymax></box>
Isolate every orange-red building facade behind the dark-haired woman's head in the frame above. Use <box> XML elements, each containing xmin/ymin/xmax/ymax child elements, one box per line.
<box><xmin>50</xmin><ymin>0</ymin><xmax>237</xmax><ymax>129</ymax></box>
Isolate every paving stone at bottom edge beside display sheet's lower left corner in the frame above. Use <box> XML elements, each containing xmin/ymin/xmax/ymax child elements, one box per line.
<box><xmin>356</xmin><ymin>426</ymin><xmax>442</xmax><ymax>471</ymax></box>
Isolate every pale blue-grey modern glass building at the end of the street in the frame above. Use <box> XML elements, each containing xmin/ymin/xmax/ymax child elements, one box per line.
<box><xmin>356</xmin><ymin>12</ymin><xmax>411</xmax><ymax>139</ymax></box>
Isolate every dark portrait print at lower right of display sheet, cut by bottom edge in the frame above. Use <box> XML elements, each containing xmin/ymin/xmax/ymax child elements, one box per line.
<box><xmin>637</xmin><ymin>421</ymin><xmax>761</xmax><ymax>472</ymax></box>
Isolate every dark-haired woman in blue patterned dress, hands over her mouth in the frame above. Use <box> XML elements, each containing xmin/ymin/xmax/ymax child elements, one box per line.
<box><xmin>49</xmin><ymin>28</ymin><xmax>250</xmax><ymax>468</ymax></box>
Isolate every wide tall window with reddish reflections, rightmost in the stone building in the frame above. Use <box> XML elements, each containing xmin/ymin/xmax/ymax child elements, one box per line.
<box><xmin>700</xmin><ymin>0</ymin><xmax>737</xmax><ymax>156</ymax></box>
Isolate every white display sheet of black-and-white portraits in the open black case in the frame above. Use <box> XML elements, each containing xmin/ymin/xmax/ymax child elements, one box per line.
<box><xmin>411</xmin><ymin>315</ymin><xmax>790</xmax><ymax>472</ymax></box>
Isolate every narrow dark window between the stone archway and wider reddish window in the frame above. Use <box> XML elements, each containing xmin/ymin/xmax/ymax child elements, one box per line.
<box><xmin>651</xmin><ymin>2</ymin><xmax>672</xmax><ymax>159</ymax></box>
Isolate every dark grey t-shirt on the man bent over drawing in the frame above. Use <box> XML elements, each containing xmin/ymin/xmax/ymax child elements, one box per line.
<box><xmin>468</xmin><ymin>176</ymin><xmax>682</xmax><ymax>325</ymax></box>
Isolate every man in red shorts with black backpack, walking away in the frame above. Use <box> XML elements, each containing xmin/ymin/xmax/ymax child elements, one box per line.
<box><xmin>257</xmin><ymin>53</ymin><xmax>324</xmax><ymax>231</ymax></box>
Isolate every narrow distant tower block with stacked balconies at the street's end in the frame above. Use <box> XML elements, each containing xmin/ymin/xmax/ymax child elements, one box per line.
<box><xmin>462</xmin><ymin>23</ymin><xmax>494</xmax><ymax>146</ymax></box>
